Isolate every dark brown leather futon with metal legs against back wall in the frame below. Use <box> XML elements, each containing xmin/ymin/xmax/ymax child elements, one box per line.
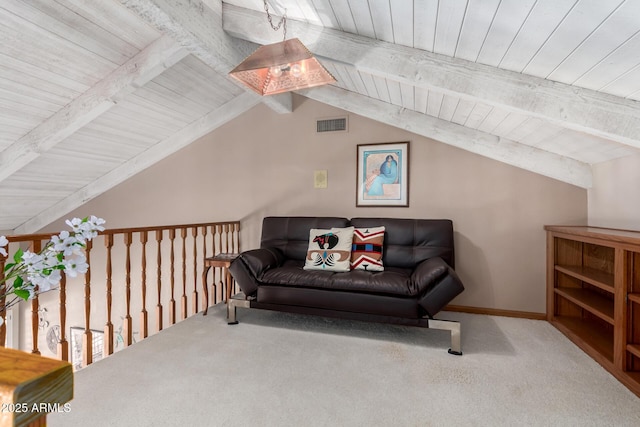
<box><xmin>228</xmin><ymin>217</ymin><xmax>464</xmax><ymax>355</ymax></box>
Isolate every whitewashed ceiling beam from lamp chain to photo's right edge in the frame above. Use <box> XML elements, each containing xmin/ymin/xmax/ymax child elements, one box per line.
<box><xmin>222</xmin><ymin>3</ymin><xmax>640</xmax><ymax>148</ymax></box>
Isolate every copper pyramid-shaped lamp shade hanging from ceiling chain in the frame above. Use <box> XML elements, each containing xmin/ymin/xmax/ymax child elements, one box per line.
<box><xmin>229</xmin><ymin>39</ymin><xmax>336</xmax><ymax>95</ymax></box>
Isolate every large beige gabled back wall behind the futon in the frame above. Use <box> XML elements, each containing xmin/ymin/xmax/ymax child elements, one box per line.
<box><xmin>47</xmin><ymin>97</ymin><xmax>587</xmax><ymax>313</ymax></box>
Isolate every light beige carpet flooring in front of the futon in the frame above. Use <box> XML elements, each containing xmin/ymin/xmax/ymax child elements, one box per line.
<box><xmin>48</xmin><ymin>305</ymin><xmax>640</xmax><ymax>427</ymax></box>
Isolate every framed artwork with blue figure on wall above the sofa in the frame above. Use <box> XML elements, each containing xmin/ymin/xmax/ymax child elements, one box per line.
<box><xmin>356</xmin><ymin>141</ymin><xmax>409</xmax><ymax>207</ymax></box>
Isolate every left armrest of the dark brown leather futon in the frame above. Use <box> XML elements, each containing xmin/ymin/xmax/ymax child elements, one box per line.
<box><xmin>229</xmin><ymin>248</ymin><xmax>284</xmax><ymax>296</ymax></box>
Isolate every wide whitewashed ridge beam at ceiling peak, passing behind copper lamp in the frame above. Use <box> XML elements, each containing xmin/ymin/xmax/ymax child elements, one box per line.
<box><xmin>118</xmin><ymin>0</ymin><xmax>293</xmax><ymax>114</ymax></box>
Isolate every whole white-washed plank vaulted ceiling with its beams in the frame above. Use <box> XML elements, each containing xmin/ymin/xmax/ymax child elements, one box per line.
<box><xmin>0</xmin><ymin>0</ymin><xmax>640</xmax><ymax>232</ymax></box>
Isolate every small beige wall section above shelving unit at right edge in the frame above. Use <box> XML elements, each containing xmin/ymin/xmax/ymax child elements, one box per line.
<box><xmin>589</xmin><ymin>155</ymin><xmax>640</xmax><ymax>230</ymax></box>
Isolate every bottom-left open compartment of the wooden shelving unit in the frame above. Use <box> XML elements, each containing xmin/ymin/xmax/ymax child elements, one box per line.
<box><xmin>553</xmin><ymin>316</ymin><xmax>613</xmax><ymax>363</ymax></box>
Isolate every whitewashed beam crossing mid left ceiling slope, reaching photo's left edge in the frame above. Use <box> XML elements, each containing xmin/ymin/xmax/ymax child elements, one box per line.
<box><xmin>0</xmin><ymin>37</ymin><xmax>188</xmax><ymax>181</ymax></box>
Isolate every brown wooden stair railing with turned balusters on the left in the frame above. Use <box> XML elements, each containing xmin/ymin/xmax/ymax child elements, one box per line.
<box><xmin>0</xmin><ymin>221</ymin><xmax>240</xmax><ymax>367</ymax></box>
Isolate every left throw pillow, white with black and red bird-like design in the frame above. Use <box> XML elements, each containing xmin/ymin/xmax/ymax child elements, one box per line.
<box><xmin>304</xmin><ymin>227</ymin><xmax>354</xmax><ymax>271</ymax></box>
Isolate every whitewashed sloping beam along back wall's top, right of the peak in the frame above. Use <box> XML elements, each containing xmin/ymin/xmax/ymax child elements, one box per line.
<box><xmin>298</xmin><ymin>86</ymin><xmax>592</xmax><ymax>188</ymax></box>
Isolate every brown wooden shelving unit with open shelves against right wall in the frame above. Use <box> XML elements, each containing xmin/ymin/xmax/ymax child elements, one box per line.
<box><xmin>545</xmin><ymin>225</ymin><xmax>640</xmax><ymax>396</ymax></box>
